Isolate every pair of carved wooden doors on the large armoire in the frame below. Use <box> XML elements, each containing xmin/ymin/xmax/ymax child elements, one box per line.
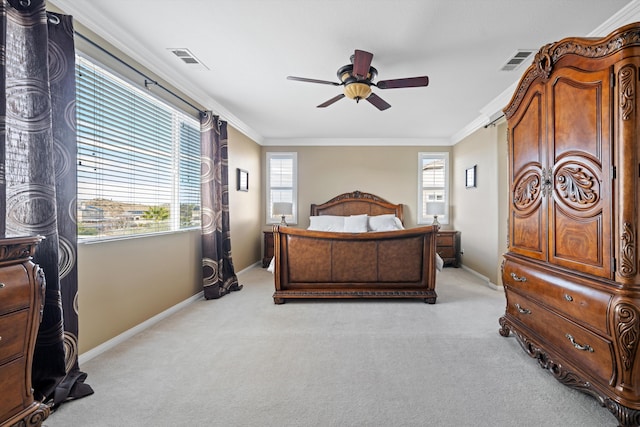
<box><xmin>509</xmin><ymin>67</ymin><xmax>613</xmax><ymax>278</ymax></box>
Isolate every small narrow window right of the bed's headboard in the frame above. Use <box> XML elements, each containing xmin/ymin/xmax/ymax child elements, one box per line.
<box><xmin>418</xmin><ymin>153</ymin><xmax>449</xmax><ymax>224</ymax></box>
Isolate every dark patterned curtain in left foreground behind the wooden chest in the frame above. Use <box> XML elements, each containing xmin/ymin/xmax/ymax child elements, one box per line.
<box><xmin>0</xmin><ymin>0</ymin><xmax>93</xmax><ymax>405</ymax></box>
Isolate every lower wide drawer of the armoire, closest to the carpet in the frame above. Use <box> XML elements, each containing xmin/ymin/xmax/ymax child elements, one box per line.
<box><xmin>507</xmin><ymin>290</ymin><xmax>614</xmax><ymax>385</ymax></box>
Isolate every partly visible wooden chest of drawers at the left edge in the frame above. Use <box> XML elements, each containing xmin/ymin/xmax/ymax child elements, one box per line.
<box><xmin>0</xmin><ymin>237</ymin><xmax>49</xmax><ymax>427</ymax></box>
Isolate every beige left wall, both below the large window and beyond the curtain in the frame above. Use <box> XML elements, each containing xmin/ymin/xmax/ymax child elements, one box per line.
<box><xmin>78</xmin><ymin>128</ymin><xmax>262</xmax><ymax>354</ymax></box>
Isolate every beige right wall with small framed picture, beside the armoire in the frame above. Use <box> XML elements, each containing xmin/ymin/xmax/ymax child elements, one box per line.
<box><xmin>451</xmin><ymin>126</ymin><xmax>506</xmax><ymax>284</ymax></box>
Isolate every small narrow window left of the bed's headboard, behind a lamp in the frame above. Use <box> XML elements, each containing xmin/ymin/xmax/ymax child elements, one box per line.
<box><xmin>267</xmin><ymin>152</ymin><xmax>298</xmax><ymax>224</ymax></box>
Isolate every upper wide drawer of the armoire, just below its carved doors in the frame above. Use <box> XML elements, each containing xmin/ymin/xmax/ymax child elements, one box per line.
<box><xmin>502</xmin><ymin>261</ymin><xmax>613</xmax><ymax>335</ymax></box>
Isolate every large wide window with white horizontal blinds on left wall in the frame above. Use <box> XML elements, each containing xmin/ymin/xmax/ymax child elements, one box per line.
<box><xmin>76</xmin><ymin>57</ymin><xmax>200</xmax><ymax>240</ymax></box>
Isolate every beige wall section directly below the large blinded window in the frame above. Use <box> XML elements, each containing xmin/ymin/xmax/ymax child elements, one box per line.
<box><xmin>78</xmin><ymin>230</ymin><xmax>202</xmax><ymax>354</ymax></box>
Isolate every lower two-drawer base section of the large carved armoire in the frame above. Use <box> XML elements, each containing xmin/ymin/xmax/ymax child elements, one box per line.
<box><xmin>500</xmin><ymin>254</ymin><xmax>638</xmax><ymax>425</ymax></box>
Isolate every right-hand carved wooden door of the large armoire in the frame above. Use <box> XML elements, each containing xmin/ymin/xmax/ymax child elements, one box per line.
<box><xmin>543</xmin><ymin>67</ymin><xmax>614</xmax><ymax>278</ymax></box>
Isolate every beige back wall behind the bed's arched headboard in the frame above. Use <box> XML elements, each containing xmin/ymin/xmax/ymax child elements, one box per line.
<box><xmin>261</xmin><ymin>146</ymin><xmax>451</xmax><ymax>228</ymax></box>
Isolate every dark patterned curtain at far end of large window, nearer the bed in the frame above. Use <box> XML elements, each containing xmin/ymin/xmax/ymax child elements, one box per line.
<box><xmin>200</xmin><ymin>112</ymin><xmax>242</xmax><ymax>299</ymax></box>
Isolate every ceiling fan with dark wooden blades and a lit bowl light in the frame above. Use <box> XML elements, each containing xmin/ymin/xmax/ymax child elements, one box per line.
<box><xmin>287</xmin><ymin>49</ymin><xmax>429</xmax><ymax>111</ymax></box>
